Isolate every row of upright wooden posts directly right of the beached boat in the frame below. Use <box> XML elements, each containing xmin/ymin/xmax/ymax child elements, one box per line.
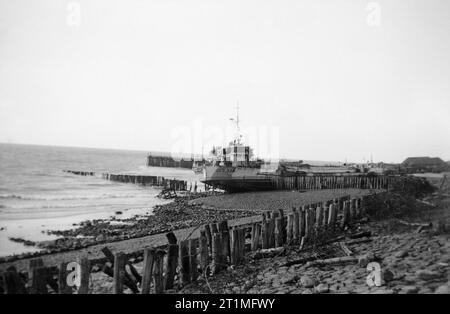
<box><xmin>271</xmin><ymin>175</ymin><xmax>399</xmax><ymax>190</ymax></box>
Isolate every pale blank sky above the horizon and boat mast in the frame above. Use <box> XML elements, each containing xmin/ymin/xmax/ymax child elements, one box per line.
<box><xmin>0</xmin><ymin>0</ymin><xmax>450</xmax><ymax>162</ymax></box>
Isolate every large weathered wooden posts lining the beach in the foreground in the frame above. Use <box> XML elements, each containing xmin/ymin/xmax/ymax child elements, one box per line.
<box><xmin>0</xmin><ymin>196</ymin><xmax>370</xmax><ymax>294</ymax></box>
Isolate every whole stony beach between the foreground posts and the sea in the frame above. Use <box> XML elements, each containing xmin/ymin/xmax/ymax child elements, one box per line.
<box><xmin>0</xmin><ymin>189</ymin><xmax>377</xmax><ymax>269</ymax></box>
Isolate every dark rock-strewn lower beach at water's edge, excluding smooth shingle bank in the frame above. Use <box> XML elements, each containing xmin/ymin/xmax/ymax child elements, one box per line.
<box><xmin>0</xmin><ymin>193</ymin><xmax>255</xmax><ymax>263</ymax></box>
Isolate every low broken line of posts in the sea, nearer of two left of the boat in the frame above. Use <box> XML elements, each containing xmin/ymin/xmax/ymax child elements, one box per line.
<box><xmin>63</xmin><ymin>170</ymin><xmax>188</xmax><ymax>191</ymax></box>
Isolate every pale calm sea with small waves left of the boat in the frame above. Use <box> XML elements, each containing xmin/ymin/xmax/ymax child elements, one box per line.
<box><xmin>0</xmin><ymin>144</ymin><xmax>202</xmax><ymax>256</ymax></box>
